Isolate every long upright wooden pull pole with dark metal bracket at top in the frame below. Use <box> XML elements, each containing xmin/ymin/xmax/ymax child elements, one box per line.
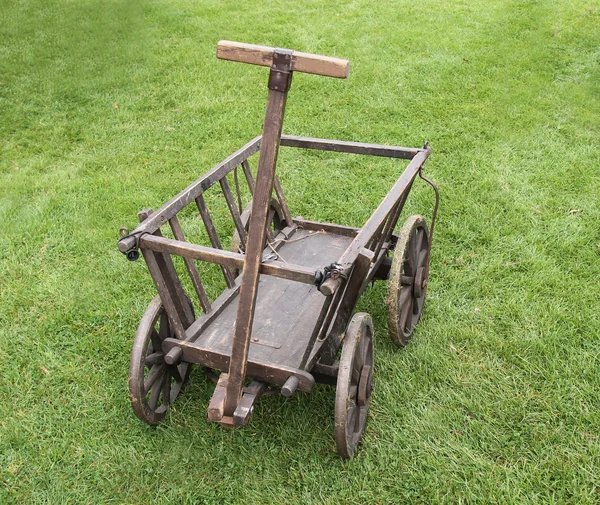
<box><xmin>223</xmin><ymin>50</ymin><xmax>292</xmax><ymax>416</ymax></box>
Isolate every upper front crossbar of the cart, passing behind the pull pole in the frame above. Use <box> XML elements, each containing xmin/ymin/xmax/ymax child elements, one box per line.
<box><xmin>140</xmin><ymin>235</ymin><xmax>316</xmax><ymax>284</ymax></box>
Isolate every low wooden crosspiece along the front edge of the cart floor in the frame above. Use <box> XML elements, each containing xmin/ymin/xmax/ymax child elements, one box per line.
<box><xmin>162</xmin><ymin>338</ymin><xmax>315</xmax><ymax>392</ymax></box>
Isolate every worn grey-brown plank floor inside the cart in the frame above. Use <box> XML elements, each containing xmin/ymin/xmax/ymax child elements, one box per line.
<box><xmin>196</xmin><ymin>229</ymin><xmax>352</xmax><ymax>368</ymax></box>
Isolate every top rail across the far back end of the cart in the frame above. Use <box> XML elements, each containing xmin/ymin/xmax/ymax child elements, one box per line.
<box><xmin>281</xmin><ymin>135</ymin><xmax>425</xmax><ymax>160</ymax></box>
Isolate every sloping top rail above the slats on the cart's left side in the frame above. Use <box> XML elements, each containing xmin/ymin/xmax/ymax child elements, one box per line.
<box><xmin>127</xmin><ymin>136</ymin><xmax>261</xmax><ymax>233</ymax></box>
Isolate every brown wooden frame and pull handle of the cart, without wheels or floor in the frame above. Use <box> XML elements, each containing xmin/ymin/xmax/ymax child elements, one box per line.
<box><xmin>119</xmin><ymin>42</ymin><xmax>438</xmax><ymax>446</ymax></box>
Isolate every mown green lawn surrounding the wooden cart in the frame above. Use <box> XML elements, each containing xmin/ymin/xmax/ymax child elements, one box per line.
<box><xmin>0</xmin><ymin>0</ymin><xmax>600</xmax><ymax>504</ymax></box>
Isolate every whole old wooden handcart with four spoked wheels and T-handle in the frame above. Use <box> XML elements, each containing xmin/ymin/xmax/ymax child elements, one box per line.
<box><xmin>119</xmin><ymin>41</ymin><xmax>439</xmax><ymax>457</ymax></box>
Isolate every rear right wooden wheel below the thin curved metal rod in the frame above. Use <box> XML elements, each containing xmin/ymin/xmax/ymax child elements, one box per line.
<box><xmin>386</xmin><ymin>216</ymin><xmax>429</xmax><ymax>347</ymax></box>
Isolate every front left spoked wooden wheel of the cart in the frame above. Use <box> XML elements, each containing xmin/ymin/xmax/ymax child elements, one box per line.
<box><xmin>129</xmin><ymin>296</ymin><xmax>191</xmax><ymax>424</ymax></box>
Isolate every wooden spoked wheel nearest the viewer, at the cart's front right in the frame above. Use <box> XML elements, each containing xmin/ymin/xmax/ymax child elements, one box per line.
<box><xmin>335</xmin><ymin>312</ymin><xmax>374</xmax><ymax>458</ymax></box>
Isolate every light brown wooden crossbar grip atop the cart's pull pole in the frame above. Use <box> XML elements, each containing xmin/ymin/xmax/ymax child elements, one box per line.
<box><xmin>217</xmin><ymin>40</ymin><xmax>350</xmax><ymax>79</ymax></box>
